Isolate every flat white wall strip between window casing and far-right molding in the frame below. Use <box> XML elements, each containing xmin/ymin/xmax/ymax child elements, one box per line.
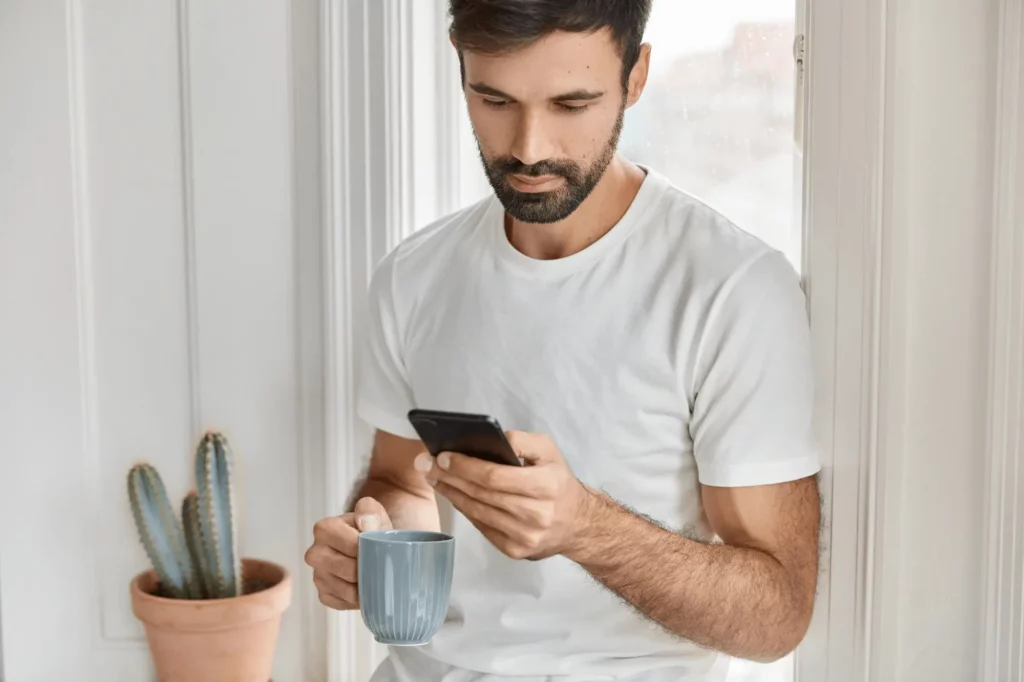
<box><xmin>880</xmin><ymin>0</ymin><xmax>1001</xmax><ymax>682</ymax></box>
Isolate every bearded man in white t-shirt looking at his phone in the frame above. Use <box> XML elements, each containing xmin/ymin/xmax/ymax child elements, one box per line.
<box><xmin>306</xmin><ymin>0</ymin><xmax>819</xmax><ymax>682</ymax></box>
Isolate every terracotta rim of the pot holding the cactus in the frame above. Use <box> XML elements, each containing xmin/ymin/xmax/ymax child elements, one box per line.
<box><xmin>130</xmin><ymin>557</ymin><xmax>292</xmax><ymax>630</ymax></box>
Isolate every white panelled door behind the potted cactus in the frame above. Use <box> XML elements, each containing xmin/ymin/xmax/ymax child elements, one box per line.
<box><xmin>0</xmin><ymin>0</ymin><xmax>311</xmax><ymax>682</ymax></box>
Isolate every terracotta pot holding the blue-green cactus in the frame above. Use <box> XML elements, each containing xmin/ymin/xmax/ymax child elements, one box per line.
<box><xmin>131</xmin><ymin>558</ymin><xmax>292</xmax><ymax>682</ymax></box>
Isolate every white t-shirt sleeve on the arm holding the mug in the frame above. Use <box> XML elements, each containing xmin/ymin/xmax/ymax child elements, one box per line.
<box><xmin>356</xmin><ymin>252</ymin><xmax>419</xmax><ymax>439</ymax></box>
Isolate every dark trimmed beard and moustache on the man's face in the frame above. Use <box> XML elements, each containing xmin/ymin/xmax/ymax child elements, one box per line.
<box><xmin>477</xmin><ymin>102</ymin><xmax>626</xmax><ymax>223</ymax></box>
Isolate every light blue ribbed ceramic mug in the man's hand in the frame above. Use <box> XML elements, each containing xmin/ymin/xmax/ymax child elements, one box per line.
<box><xmin>356</xmin><ymin>530</ymin><xmax>455</xmax><ymax>646</ymax></box>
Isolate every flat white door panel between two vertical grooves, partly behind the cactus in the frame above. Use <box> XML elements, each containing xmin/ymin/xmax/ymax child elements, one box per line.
<box><xmin>78</xmin><ymin>2</ymin><xmax>194</xmax><ymax>643</ymax></box>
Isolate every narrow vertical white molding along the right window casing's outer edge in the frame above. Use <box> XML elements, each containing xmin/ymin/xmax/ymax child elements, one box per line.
<box><xmin>856</xmin><ymin>0</ymin><xmax>912</xmax><ymax>682</ymax></box>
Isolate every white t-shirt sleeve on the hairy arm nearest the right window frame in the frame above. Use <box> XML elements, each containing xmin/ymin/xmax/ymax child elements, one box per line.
<box><xmin>690</xmin><ymin>246</ymin><xmax>820</xmax><ymax>487</ymax></box>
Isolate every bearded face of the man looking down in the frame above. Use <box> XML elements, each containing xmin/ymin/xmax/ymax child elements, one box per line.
<box><xmin>464</xmin><ymin>30</ymin><xmax>632</xmax><ymax>223</ymax></box>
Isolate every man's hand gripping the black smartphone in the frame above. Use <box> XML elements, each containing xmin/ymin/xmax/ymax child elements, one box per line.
<box><xmin>416</xmin><ymin>431</ymin><xmax>591</xmax><ymax>560</ymax></box>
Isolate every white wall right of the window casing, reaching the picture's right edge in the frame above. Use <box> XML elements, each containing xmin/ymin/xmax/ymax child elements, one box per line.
<box><xmin>868</xmin><ymin>0</ymin><xmax>1024</xmax><ymax>682</ymax></box>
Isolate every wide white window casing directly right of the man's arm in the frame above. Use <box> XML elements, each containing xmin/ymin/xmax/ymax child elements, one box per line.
<box><xmin>797</xmin><ymin>0</ymin><xmax>906</xmax><ymax>682</ymax></box>
